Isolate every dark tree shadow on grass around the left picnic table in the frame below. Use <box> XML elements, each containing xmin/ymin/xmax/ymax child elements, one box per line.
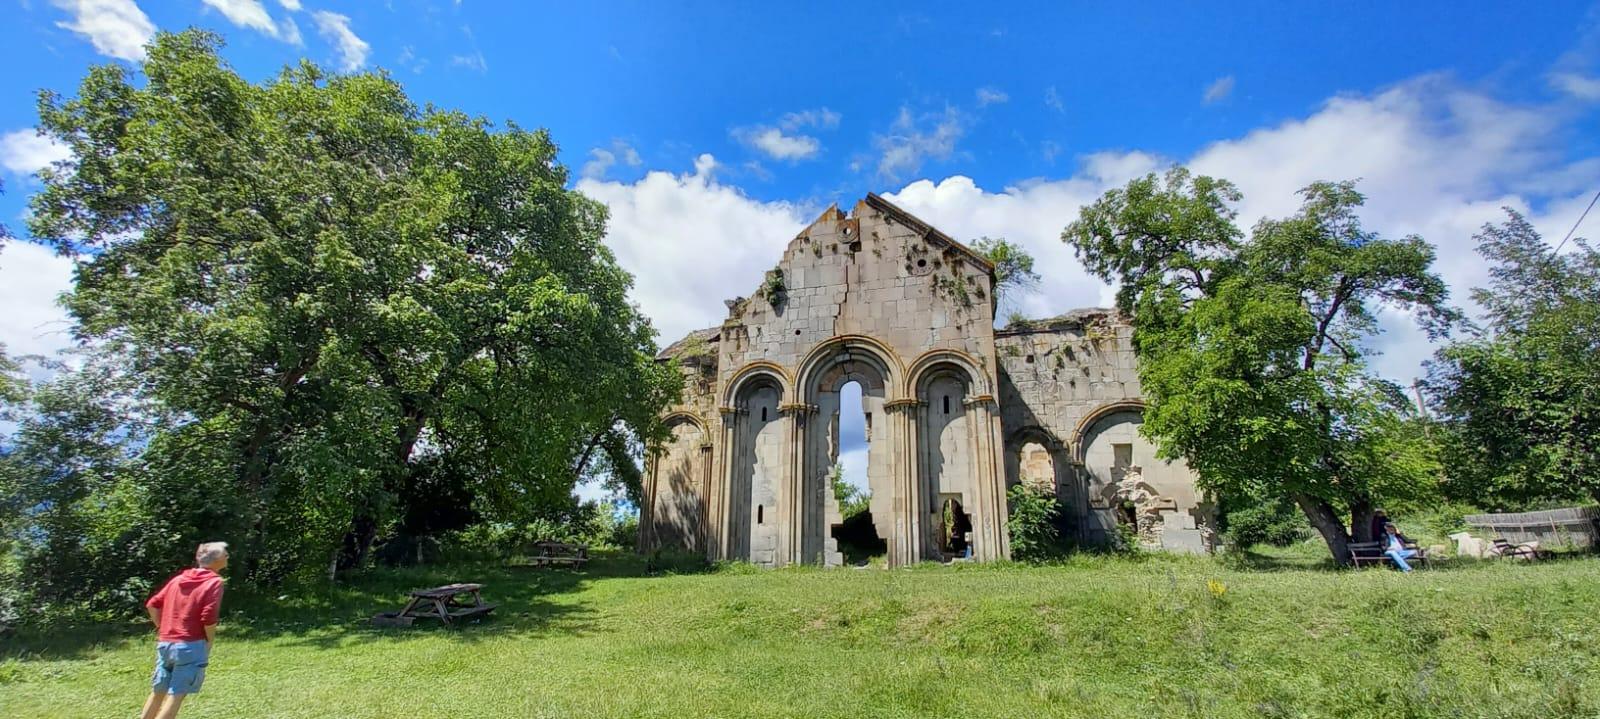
<box><xmin>0</xmin><ymin>554</ymin><xmax>684</xmax><ymax>661</ymax></box>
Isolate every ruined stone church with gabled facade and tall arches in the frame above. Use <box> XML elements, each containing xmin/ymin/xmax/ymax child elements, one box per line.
<box><xmin>640</xmin><ymin>194</ymin><xmax>1211</xmax><ymax>567</ymax></box>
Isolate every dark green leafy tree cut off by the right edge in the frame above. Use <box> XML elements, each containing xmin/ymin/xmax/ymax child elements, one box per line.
<box><xmin>1429</xmin><ymin>210</ymin><xmax>1600</xmax><ymax>508</ymax></box>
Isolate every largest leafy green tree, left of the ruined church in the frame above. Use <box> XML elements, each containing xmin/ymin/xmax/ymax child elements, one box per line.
<box><xmin>29</xmin><ymin>32</ymin><xmax>674</xmax><ymax>576</ymax></box>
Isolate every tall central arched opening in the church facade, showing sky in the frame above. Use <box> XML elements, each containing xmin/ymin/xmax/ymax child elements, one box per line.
<box><xmin>829</xmin><ymin>380</ymin><xmax>888</xmax><ymax>565</ymax></box>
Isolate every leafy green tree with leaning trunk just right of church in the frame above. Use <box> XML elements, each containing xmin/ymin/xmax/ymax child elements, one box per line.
<box><xmin>1062</xmin><ymin>168</ymin><xmax>1454</xmax><ymax>564</ymax></box>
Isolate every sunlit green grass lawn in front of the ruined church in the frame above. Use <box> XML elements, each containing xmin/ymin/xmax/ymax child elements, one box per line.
<box><xmin>0</xmin><ymin>547</ymin><xmax>1600</xmax><ymax>719</ymax></box>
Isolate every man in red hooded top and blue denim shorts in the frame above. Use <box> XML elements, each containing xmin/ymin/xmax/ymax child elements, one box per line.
<box><xmin>144</xmin><ymin>541</ymin><xmax>227</xmax><ymax>719</ymax></box>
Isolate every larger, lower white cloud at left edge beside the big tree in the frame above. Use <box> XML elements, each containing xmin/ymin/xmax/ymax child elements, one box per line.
<box><xmin>0</xmin><ymin>242</ymin><xmax>72</xmax><ymax>357</ymax></box>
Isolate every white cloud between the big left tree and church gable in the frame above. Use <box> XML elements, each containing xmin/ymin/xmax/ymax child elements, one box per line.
<box><xmin>578</xmin><ymin>155</ymin><xmax>806</xmax><ymax>344</ymax></box>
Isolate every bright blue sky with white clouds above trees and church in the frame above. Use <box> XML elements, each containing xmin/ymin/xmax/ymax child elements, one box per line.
<box><xmin>0</xmin><ymin>0</ymin><xmax>1600</xmax><ymax>493</ymax></box>
